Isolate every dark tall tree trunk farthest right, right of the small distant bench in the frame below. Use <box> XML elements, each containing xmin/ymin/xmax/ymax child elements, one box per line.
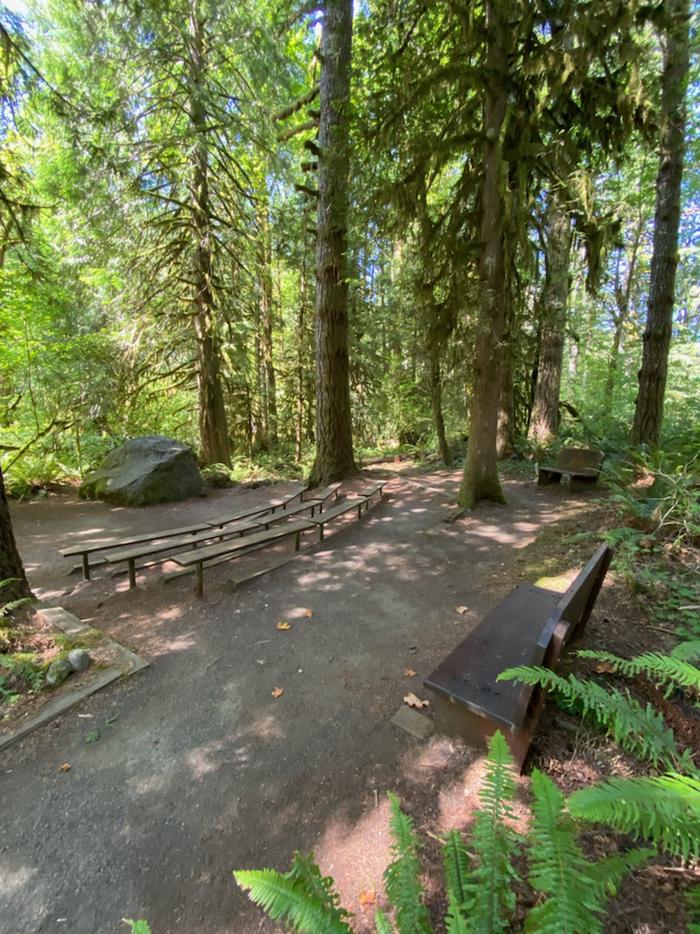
<box><xmin>632</xmin><ymin>0</ymin><xmax>690</xmax><ymax>446</ymax></box>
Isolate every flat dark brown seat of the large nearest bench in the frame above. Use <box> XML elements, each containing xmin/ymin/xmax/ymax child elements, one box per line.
<box><xmin>424</xmin><ymin>584</ymin><xmax>561</xmax><ymax>729</ymax></box>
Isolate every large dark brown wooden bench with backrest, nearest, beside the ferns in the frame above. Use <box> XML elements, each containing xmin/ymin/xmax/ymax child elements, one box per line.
<box><xmin>423</xmin><ymin>545</ymin><xmax>612</xmax><ymax>768</ymax></box>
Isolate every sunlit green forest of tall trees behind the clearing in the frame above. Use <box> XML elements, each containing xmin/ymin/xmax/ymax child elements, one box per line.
<box><xmin>0</xmin><ymin>0</ymin><xmax>700</xmax><ymax>520</ymax></box>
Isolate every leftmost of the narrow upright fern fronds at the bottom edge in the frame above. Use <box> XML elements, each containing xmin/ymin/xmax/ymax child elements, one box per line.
<box><xmin>384</xmin><ymin>793</ymin><xmax>431</xmax><ymax>934</ymax></box>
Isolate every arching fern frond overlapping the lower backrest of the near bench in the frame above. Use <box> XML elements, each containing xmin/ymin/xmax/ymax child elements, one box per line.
<box><xmin>497</xmin><ymin>665</ymin><xmax>692</xmax><ymax>769</ymax></box>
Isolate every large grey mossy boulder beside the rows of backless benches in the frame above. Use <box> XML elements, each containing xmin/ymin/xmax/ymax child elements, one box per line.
<box><xmin>80</xmin><ymin>435</ymin><xmax>206</xmax><ymax>506</ymax></box>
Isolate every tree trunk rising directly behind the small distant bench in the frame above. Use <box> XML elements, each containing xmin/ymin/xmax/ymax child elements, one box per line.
<box><xmin>528</xmin><ymin>189</ymin><xmax>571</xmax><ymax>445</ymax></box>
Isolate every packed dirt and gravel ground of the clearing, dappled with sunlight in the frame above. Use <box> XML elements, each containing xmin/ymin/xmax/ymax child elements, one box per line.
<box><xmin>0</xmin><ymin>463</ymin><xmax>687</xmax><ymax>934</ymax></box>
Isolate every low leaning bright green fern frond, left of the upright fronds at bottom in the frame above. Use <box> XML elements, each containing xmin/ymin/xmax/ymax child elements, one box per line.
<box><xmin>233</xmin><ymin>853</ymin><xmax>350</xmax><ymax>934</ymax></box>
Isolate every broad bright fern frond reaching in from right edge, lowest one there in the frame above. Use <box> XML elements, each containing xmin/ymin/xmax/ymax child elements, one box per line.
<box><xmin>567</xmin><ymin>773</ymin><xmax>700</xmax><ymax>860</ymax></box>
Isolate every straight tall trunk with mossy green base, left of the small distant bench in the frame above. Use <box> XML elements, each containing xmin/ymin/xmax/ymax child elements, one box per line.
<box><xmin>457</xmin><ymin>0</ymin><xmax>509</xmax><ymax>508</ymax></box>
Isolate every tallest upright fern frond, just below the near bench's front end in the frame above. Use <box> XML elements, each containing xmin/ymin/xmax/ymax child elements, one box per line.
<box><xmin>465</xmin><ymin>731</ymin><xmax>518</xmax><ymax>934</ymax></box>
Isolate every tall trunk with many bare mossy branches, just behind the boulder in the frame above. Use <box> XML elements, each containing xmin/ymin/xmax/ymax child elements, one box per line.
<box><xmin>188</xmin><ymin>0</ymin><xmax>231</xmax><ymax>466</ymax></box>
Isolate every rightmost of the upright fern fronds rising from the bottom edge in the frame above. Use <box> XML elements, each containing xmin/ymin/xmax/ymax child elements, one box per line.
<box><xmin>527</xmin><ymin>769</ymin><xmax>603</xmax><ymax>934</ymax></box>
